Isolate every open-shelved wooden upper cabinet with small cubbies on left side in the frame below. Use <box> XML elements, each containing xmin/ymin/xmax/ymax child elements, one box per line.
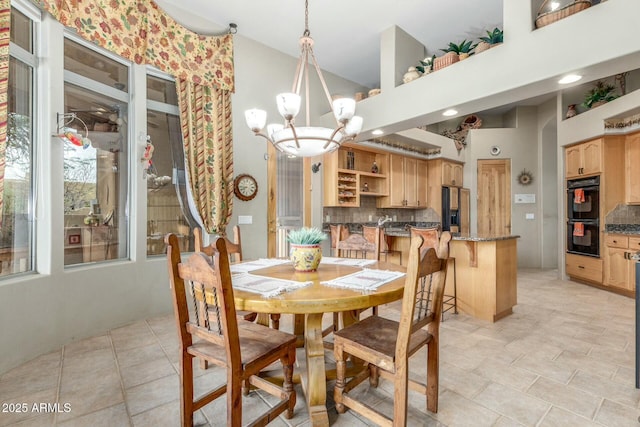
<box><xmin>323</xmin><ymin>144</ymin><xmax>389</xmax><ymax>207</ymax></box>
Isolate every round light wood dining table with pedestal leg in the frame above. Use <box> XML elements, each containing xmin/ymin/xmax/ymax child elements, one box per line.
<box><xmin>234</xmin><ymin>262</ymin><xmax>406</xmax><ymax>426</ymax></box>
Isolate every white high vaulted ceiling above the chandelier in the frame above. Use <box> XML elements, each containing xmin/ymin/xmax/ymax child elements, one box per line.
<box><xmin>152</xmin><ymin>0</ymin><xmax>503</xmax><ymax>88</ymax></box>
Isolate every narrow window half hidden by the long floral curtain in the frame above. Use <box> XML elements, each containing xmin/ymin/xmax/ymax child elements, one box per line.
<box><xmin>146</xmin><ymin>75</ymin><xmax>195</xmax><ymax>255</ymax></box>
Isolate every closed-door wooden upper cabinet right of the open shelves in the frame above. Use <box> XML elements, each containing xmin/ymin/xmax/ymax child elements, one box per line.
<box><xmin>377</xmin><ymin>154</ymin><xmax>427</xmax><ymax>208</ymax></box>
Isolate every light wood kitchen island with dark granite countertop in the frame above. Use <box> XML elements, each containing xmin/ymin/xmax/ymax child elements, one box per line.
<box><xmin>387</xmin><ymin>229</ymin><xmax>520</xmax><ymax>322</ymax></box>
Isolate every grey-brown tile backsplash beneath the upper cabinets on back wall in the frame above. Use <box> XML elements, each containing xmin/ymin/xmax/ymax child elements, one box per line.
<box><xmin>322</xmin><ymin>197</ymin><xmax>440</xmax><ymax>223</ymax></box>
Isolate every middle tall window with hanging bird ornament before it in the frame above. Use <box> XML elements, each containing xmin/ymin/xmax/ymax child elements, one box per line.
<box><xmin>58</xmin><ymin>38</ymin><xmax>129</xmax><ymax>265</ymax></box>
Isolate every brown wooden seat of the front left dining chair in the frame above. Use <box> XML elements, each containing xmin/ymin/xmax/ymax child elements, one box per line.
<box><xmin>188</xmin><ymin>319</ymin><xmax>297</xmax><ymax>366</ymax></box>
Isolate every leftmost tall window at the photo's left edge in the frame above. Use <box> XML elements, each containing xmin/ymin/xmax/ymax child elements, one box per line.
<box><xmin>0</xmin><ymin>9</ymin><xmax>36</xmax><ymax>276</ymax></box>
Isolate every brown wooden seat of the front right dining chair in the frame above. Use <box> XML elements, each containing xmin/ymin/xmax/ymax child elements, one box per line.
<box><xmin>334</xmin><ymin>316</ymin><xmax>432</xmax><ymax>369</ymax></box>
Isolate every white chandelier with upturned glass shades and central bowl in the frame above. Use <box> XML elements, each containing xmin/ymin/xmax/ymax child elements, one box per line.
<box><xmin>244</xmin><ymin>0</ymin><xmax>362</xmax><ymax>157</ymax></box>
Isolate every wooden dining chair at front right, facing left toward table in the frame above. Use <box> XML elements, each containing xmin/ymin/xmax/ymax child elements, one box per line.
<box><xmin>334</xmin><ymin>237</ymin><xmax>447</xmax><ymax>426</ymax></box>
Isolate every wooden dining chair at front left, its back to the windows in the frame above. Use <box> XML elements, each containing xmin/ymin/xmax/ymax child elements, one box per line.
<box><xmin>165</xmin><ymin>234</ymin><xmax>296</xmax><ymax>427</ymax></box>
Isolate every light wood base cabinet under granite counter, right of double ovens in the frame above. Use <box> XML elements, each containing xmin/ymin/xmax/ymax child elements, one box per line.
<box><xmin>604</xmin><ymin>234</ymin><xmax>640</xmax><ymax>292</ymax></box>
